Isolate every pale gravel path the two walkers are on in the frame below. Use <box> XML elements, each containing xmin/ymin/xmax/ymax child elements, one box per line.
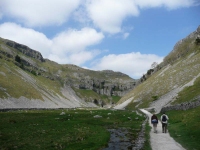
<box><xmin>141</xmin><ymin>109</ymin><xmax>185</xmax><ymax>150</ymax></box>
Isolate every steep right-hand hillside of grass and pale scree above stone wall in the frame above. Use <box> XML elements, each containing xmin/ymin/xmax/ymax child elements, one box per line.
<box><xmin>118</xmin><ymin>27</ymin><xmax>200</xmax><ymax>112</ymax></box>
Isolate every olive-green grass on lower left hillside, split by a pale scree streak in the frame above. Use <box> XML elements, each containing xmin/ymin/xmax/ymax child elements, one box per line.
<box><xmin>0</xmin><ymin>60</ymin><xmax>63</xmax><ymax>100</ymax></box>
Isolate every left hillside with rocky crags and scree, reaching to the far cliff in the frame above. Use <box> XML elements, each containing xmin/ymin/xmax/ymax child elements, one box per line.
<box><xmin>0</xmin><ymin>38</ymin><xmax>136</xmax><ymax>108</ymax></box>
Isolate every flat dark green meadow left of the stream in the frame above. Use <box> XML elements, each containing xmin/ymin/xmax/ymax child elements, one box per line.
<box><xmin>0</xmin><ymin>109</ymin><xmax>144</xmax><ymax>150</ymax></box>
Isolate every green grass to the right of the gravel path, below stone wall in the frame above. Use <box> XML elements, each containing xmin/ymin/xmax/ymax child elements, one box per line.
<box><xmin>167</xmin><ymin>107</ymin><xmax>200</xmax><ymax>150</ymax></box>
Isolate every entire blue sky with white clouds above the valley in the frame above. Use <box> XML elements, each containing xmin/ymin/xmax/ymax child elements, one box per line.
<box><xmin>0</xmin><ymin>0</ymin><xmax>200</xmax><ymax>79</ymax></box>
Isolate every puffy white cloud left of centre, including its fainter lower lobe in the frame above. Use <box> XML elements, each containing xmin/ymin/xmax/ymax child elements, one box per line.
<box><xmin>52</xmin><ymin>28</ymin><xmax>104</xmax><ymax>65</ymax></box>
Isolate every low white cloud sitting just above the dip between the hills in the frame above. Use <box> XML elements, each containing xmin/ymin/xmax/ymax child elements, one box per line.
<box><xmin>91</xmin><ymin>52</ymin><xmax>163</xmax><ymax>79</ymax></box>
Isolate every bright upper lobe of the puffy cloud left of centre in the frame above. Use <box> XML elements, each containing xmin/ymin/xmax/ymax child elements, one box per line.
<box><xmin>53</xmin><ymin>28</ymin><xmax>104</xmax><ymax>54</ymax></box>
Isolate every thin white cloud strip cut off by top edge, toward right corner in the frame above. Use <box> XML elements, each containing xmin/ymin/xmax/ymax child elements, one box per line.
<box><xmin>135</xmin><ymin>0</ymin><xmax>196</xmax><ymax>10</ymax></box>
